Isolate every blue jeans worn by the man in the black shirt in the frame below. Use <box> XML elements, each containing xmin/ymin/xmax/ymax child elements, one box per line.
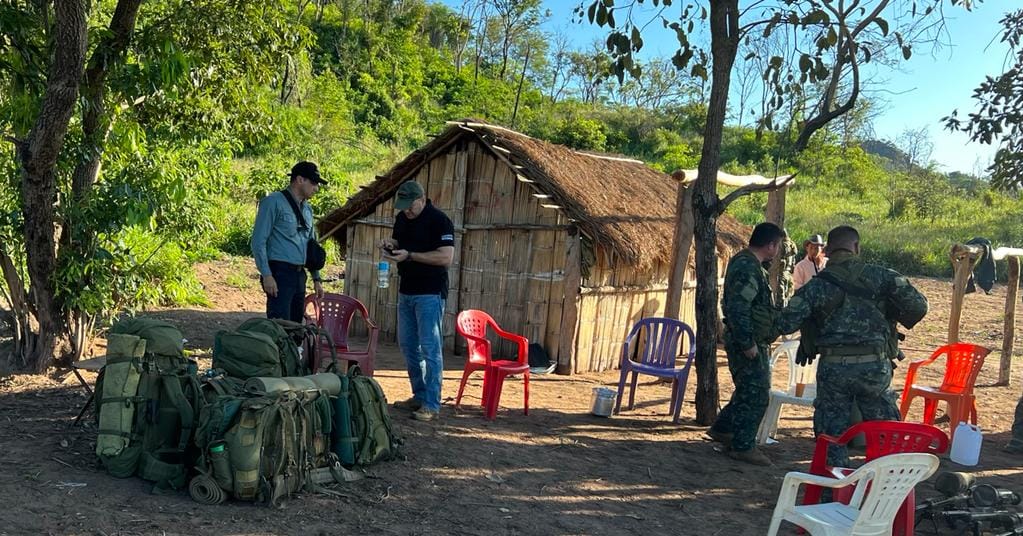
<box><xmin>398</xmin><ymin>293</ymin><xmax>444</xmax><ymax>411</ymax></box>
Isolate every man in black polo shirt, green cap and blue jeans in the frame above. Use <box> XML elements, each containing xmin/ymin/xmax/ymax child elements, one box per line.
<box><xmin>377</xmin><ymin>181</ymin><xmax>454</xmax><ymax>420</ymax></box>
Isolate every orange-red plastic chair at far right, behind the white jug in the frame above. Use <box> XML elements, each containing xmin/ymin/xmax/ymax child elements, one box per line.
<box><xmin>899</xmin><ymin>343</ymin><xmax>991</xmax><ymax>434</ymax></box>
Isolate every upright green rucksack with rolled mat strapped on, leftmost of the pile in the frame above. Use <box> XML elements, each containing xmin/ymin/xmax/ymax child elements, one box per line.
<box><xmin>96</xmin><ymin>318</ymin><xmax>203</xmax><ymax>489</ymax></box>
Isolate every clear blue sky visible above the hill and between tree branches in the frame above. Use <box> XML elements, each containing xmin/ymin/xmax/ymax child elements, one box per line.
<box><xmin>444</xmin><ymin>0</ymin><xmax>1020</xmax><ymax>173</ymax></box>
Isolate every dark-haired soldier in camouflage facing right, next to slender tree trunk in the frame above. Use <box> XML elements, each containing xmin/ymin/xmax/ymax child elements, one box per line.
<box><xmin>707</xmin><ymin>223</ymin><xmax>783</xmax><ymax>465</ymax></box>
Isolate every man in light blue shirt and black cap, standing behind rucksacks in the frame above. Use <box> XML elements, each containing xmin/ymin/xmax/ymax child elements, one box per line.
<box><xmin>252</xmin><ymin>162</ymin><xmax>326</xmax><ymax>322</ymax></box>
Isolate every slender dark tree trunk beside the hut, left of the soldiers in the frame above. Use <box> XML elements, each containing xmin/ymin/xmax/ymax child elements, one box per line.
<box><xmin>693</xmin><ymin>0</ymin><xmax>740</xmax><ymax>425</ymax></box>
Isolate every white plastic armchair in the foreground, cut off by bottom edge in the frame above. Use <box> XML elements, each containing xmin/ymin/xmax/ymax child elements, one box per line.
<box><xmin>767</xmin><ymin>453</ymin><xmax>938</xmax><ymax>536</ymax></box>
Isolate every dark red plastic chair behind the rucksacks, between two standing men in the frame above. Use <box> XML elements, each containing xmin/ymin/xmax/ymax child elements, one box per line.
<box><xmin>306</xmin><ymin>293</ymin><xmax>380</xmax><ymax>376</ymax></box>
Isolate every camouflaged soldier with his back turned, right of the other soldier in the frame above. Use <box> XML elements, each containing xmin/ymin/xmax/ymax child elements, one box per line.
<box><xmin>776</xmin><ymin>226</ymin><xmax>927</xmax><ymax>466</ymax></box>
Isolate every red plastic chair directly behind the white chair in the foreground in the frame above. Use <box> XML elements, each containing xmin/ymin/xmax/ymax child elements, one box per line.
<box><xmin>803</xmin><ymin>420</ymin><xmax>948</xmax><ymax>536</ymax></box>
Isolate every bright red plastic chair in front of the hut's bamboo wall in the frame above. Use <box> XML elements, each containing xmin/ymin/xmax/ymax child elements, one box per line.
<box><xmin>454</xmin><ymin>309</ymin><xmax>529</xmax><ymax>419</ymax></box>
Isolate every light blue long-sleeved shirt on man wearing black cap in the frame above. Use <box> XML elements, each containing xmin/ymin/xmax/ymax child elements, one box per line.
<box><xmin>252</xmin><ymin>191</ymin><xmax>319</xmax><ymax>279</ymax></box>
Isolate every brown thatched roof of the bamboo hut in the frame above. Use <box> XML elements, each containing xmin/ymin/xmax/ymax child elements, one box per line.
<box><xmin>317</xmin><ymin>121</ymin><xmax>750</xmax><ymax>266</ymax></box>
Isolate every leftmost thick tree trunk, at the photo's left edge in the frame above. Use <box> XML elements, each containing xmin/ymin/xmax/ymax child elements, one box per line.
<box><xmin>17</xmin><ymin>0</ymin><xmax>87</xmax><ymax>372</ymax></box>
